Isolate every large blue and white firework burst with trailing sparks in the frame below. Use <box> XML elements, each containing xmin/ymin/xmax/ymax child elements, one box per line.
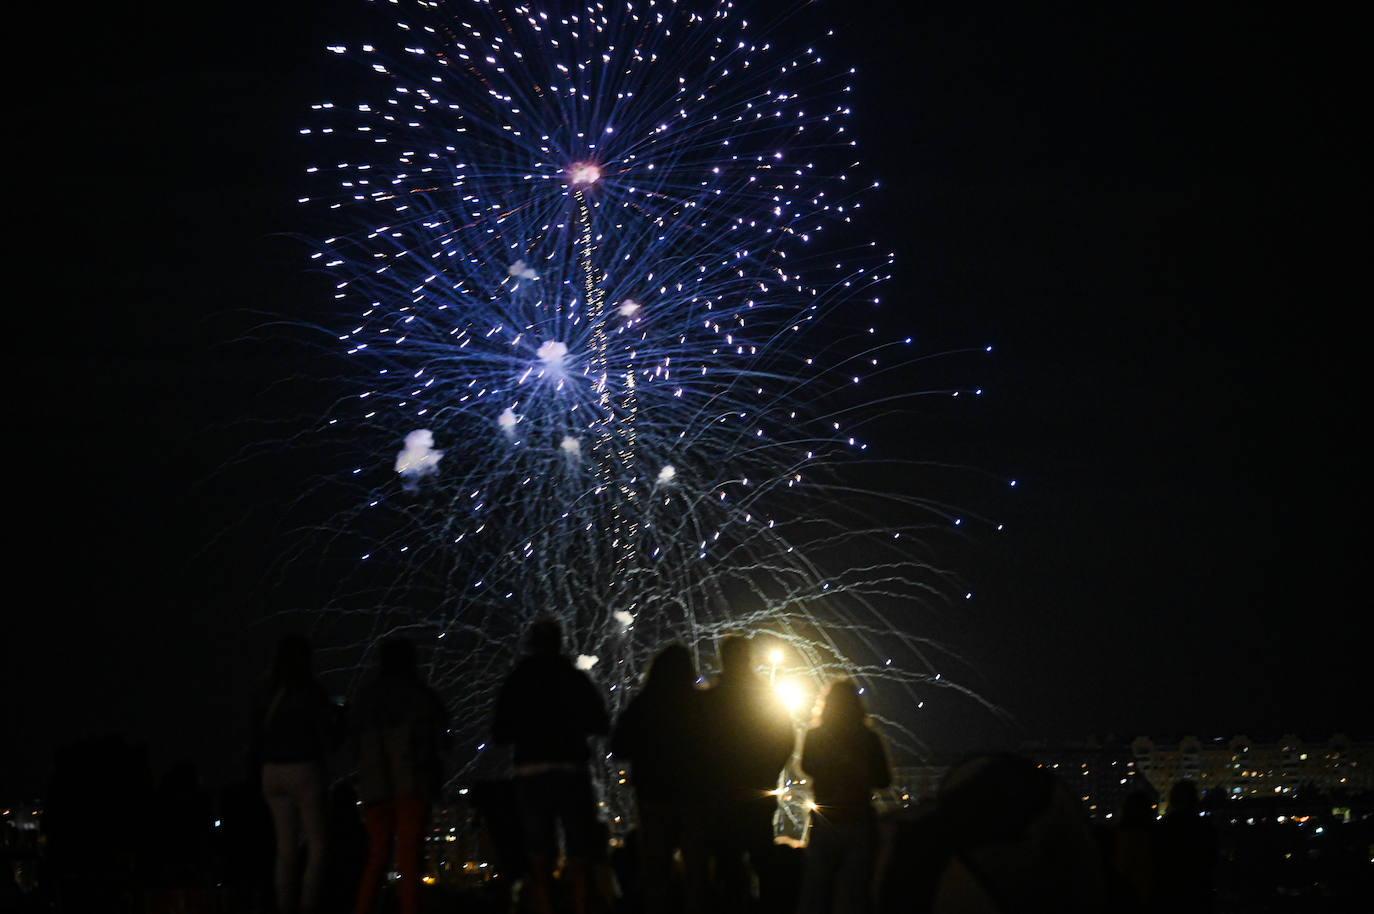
<box><xmin>287</xmin><ymin>0</ymin><xmax>1000</xmax><ymax>797</ymax></box>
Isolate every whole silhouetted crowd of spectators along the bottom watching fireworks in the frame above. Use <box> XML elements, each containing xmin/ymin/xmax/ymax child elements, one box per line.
<box><xmin>26</xmin><ymin>618</ymin><xmax>1242</xmax><ymax>914</ymax></box>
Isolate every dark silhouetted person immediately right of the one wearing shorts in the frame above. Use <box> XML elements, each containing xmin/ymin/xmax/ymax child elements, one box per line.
<box><xmin>610</xmin><ymin>643</ymin><xmax>703</xmax><ymax>914</ymax></box>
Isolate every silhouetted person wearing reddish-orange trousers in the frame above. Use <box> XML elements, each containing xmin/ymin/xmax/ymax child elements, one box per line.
<box><xmin>353</xmin><ymin>638</ymin><xmax>448</xmax><ymax>914</ymax></box>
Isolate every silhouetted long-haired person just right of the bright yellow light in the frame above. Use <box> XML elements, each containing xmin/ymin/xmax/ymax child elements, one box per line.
<box><xmin>801</xmin><ymin>679</ymin><xmax>892</xmax><ymax>914</ymax></box>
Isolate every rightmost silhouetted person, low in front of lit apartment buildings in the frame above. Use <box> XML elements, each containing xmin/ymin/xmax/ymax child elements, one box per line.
<box><xmin>1151</xmin><ymin>781</ymin><xmax>1217</xmax><ymax>911</ymax></box>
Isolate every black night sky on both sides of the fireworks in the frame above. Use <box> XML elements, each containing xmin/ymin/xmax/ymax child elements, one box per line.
<box><xmin>0</xmin><ymin>0</ymin><xmax>1367</xmax><ymax>797</ymax></box>
